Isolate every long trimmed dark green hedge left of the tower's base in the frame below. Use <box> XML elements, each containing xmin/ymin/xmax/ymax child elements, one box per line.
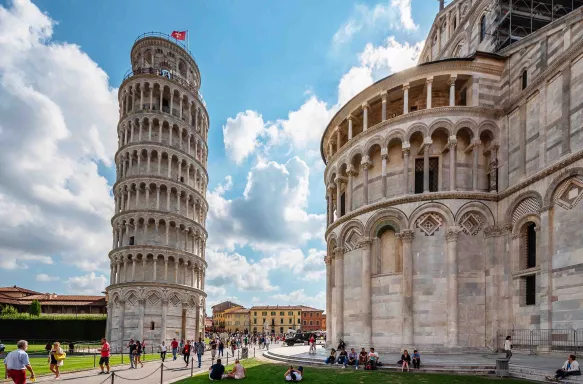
<box><xmin>0</xmin><ymin>316</ymin><xmax>106</xmax><ymax>341</ymax></box>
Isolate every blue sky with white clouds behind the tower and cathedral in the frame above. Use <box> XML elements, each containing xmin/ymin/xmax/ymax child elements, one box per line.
<box><xmin>0</xmin><ymin>0</ymin><xmax>438</xmax><ymax>308</ymax></box>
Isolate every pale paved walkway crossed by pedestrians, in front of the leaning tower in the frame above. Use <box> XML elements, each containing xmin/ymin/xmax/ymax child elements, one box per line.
<box><xmin>30</xmin><ymin>344</ymin><xmax>281</xmax><ymax>384</ymax></box>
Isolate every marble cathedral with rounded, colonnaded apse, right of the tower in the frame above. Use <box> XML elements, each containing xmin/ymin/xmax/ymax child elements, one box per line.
<box><xmin>321</xmin><ymin>0</ymin><xmax>583</xmax><ymax>351</ymax></box>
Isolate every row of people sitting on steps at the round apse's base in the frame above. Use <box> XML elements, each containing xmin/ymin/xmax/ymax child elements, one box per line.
<box><xmin>325</xmin><ymin>340</ymin><xmax>421</xmax><ymax>371</ymax></box>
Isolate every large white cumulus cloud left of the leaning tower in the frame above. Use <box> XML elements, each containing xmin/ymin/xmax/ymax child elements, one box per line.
<box><xmin>0</xmin><ymin>0</ymin><xmax>118</xmax><ymax>270</ymax></box>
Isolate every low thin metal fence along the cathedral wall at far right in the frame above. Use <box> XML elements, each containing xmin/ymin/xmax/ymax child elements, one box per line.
<box><xmin>496</xmin><ymin>328</ymin><xmax>583</xmax><ymax>355</ymax></box>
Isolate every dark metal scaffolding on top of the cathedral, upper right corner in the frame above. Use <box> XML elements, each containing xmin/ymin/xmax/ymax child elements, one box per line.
<box><xmin>492</xmin><ymin>0</ymin><xmax>583</xmax><ymax>51</ymax></box>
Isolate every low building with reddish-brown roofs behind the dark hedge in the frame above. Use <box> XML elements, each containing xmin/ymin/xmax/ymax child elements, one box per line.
<box><xmin>0</xmin><ymin>285</ymin><xmax>107</xmax><ymax>315</ymax></box>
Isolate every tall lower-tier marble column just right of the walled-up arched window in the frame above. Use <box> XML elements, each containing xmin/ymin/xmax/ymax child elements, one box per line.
<box><xmin>398</xmin><ymin>229</ymin><xmax>415</xmax><ymax>348</ymax></box>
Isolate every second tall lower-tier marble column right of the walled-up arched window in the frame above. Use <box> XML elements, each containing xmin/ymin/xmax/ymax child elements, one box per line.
<box><xmin>445</xmin><ymin>227</ymin><xmax>461</xmax><ymax>347</ymax></box>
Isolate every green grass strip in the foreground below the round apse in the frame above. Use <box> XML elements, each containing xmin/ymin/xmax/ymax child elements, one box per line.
<box><xmin>178</xmin><ymin>359</ymin><xmax>524</xmax><ymax>384</ymax></box>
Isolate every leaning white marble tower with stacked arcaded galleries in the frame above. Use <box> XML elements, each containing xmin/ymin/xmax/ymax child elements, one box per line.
<box><xmin>106</xmin><ymin>33</ymin><xmax>209</xmax><ymax>348</ymax></box>
